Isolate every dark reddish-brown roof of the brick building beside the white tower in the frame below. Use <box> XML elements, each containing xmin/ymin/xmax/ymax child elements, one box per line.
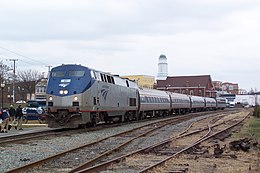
<box><xmin>157</xmin><ymin>75</ymin><xmax>213</xmax><ymax>87</ymax></box>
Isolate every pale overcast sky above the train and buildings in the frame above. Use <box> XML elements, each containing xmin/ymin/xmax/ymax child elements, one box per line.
<box><xmin>0</xmin><ymin>0</ymin><xmax>260</xmax><ymax>90</ymax></box>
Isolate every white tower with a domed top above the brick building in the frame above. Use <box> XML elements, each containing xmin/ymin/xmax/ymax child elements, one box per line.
<box><xmin>157</xmin><ymin>54</ymin><xmax>168</xmax><ymax>80</ymax></box>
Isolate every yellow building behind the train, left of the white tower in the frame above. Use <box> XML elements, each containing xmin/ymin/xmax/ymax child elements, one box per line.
<box><xmin>121</xmin><ymin>75</ymin><xmax>155</xmax><ymax>88</ymax></box>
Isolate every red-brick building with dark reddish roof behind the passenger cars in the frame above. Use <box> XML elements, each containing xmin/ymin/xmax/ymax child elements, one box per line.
<box><xmin>156</xmin><ymin>75</ymin><xmax>216</xmax><ymax>97</ymax></box>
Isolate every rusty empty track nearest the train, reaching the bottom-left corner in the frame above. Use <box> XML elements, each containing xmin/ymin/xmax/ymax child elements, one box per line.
<box><xmin>3</xmin><ymin>112</ymin><xmax>225</xmax><ymax>172</ymax></box>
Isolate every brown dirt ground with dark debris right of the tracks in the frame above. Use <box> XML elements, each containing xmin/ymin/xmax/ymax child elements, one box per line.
<box><xmin>160</xmin><ymin>110</ymin><xmax>260</xmax><ymax>173</ymax></box>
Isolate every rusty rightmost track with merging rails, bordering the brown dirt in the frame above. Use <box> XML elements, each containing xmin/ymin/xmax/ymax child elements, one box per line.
<box><xmin>70</xmin><ymin>109</ymin><xmax>249</xmax><ymax>173</ymax></box>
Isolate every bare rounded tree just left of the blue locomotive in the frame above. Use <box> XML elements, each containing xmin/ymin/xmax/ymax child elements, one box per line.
<box><xmin>17</xmin><ymin>69</ymin><xmax>42</xmax><ymax>99</ymax></box>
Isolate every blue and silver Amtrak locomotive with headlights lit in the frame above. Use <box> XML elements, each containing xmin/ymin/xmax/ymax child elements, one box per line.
<box><xmin>46</xmin><ymin>65</ymin><xmax>139</xmax><ymax>128</ymax></box>
